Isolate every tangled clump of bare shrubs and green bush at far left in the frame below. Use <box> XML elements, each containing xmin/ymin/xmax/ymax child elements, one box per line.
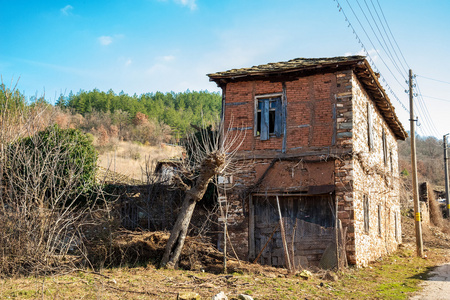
<box><xmin>0</xmin><ymin>127</ymin><xmax>96</xmax><ymax>275</ymax></box>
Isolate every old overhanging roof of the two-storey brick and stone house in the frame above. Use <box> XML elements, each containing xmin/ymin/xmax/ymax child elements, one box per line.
<box><xmin>208</xmin><ymin>55</ymin><xmax>408</xmax><ymax>140</ymax></box>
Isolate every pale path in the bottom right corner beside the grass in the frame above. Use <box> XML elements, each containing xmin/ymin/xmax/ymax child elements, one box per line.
<box><xmin>410</xmin><ymin>263</ymin><xmax>450</xmax><ymax>300</ymax></box>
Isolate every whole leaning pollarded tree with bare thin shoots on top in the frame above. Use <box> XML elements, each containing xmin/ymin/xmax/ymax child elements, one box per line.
<box><xmin>161</xmin><ymin>123</ymin><xmax>243</xmax><ymax>268</ymax></box>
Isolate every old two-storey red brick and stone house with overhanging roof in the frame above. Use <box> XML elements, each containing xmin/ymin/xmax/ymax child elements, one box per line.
<box><xmin>208</xmin><ymin>56</ymin><xmax>407</xmax><ymax>266</ymax></box>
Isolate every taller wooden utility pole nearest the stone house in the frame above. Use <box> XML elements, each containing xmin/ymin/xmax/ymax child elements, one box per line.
<box><xmin>409</xmin><ymin>69</ymin><xmax>423</xmax><ymax>257</ymax></box>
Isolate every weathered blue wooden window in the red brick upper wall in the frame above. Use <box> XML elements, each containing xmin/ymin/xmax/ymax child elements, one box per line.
<box><xmin>255</xmin><ymin>95</ymin><xmax>283</xmax><ymax>141</ymax></box>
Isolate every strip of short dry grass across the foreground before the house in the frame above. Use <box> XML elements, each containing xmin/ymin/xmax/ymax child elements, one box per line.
<box><xmin>0</xmin><ymin>248</ymin><xmax>448</xmax><ymax>299</ymax></box>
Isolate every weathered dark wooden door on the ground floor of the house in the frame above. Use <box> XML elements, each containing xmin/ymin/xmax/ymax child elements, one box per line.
<box><xmin>250</xmin><ymin>194</ymin><xmax>335</xmax><ymax>268</ymax></box>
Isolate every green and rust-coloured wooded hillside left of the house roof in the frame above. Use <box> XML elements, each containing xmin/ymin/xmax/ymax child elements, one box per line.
<box><xmin>56</xmin><ymin>89</ymin><xmax>222</xmax><ymax>143</ymax></box>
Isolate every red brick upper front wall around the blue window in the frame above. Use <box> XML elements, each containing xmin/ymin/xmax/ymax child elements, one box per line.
<box><xmin>225</xmin><ymin>73</ymin><xmax>337</xmax><ymax>153</ymax></box>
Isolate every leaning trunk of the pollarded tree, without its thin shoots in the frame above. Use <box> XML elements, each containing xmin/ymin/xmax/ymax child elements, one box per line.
<box><xmin>161</xmin><ymin>151</ymin><xmax>225</xmax><ymax>269</ymax></box>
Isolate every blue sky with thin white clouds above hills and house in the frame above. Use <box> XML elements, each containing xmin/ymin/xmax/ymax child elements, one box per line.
<box><xmin>0</xmin><ymin>0</ymin><xmax>450</xmax><ymax>138</ymax></box>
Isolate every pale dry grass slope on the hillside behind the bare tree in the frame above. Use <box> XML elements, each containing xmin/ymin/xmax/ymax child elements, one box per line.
<box><xmin>98</xmin><ymin>141</ymin><xmax>181</xmax><ymax>181</ymax></box>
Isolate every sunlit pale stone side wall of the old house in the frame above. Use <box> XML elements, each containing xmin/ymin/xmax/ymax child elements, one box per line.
<box><xmin>352</xmin><ymin>76</ymin><xmax>401</xmax><ymax>266</ymax></box>
